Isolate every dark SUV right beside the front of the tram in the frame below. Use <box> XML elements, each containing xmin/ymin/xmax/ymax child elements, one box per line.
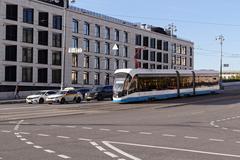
<box><xmin>85</xmin><ymin>86</ymin><xmax>113</xmax><ymax>101</ymax></box>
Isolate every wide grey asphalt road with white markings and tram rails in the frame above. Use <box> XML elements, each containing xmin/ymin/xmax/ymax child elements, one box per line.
<box><xmin>0</xmin><ymin>87</ymin><xmax>240</xmax><ymax>160</ymax></box>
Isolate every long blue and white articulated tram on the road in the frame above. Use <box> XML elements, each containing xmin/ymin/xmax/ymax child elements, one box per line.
<box><xmin>113</xmin><ymin>69</ymin><xmax>220</xmax><ymax>103</ymax></box>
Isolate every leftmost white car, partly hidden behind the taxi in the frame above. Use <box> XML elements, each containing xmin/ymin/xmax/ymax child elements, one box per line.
<box><xmin>26</xmin><ymin>90</ymin><xmax>56</xmax><ymax>104</ymax></box>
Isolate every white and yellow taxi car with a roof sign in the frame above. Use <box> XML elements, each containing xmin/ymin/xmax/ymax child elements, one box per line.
<box><xmin>46</xmin><ymin>90</ymin><xmax>83</xmax><ymax>104</ymax></box>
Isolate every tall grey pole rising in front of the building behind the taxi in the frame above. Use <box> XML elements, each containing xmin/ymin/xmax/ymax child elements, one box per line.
<box><xmin>61</xmin><ymin>0</ymin><xmax>75</xmax><ymax>90</ymax></box>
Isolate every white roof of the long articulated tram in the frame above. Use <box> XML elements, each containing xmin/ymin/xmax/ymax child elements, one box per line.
<box><xmin>114</xmin><ymin>68</ymin><xmax>219</xmax><ymax>76</ymax></box>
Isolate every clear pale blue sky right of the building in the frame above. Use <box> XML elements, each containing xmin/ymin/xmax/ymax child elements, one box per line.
<box><xmin>74</xmin><ymin>0</ymin><xmax>240</xmax><ymax>70</ymax></box>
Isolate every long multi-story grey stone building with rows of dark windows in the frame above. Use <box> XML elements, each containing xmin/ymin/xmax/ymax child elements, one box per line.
<box><xmin>0</xmin><ymin>0</ymin><xmax>193</xmax><ymax>98</ymax></box>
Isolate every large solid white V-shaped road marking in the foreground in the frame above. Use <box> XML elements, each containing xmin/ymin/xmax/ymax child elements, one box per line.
<box><xmin>103</xmin><ymin>141</ymin><xmax>240</xmax><ymax>160</ymax></box>
